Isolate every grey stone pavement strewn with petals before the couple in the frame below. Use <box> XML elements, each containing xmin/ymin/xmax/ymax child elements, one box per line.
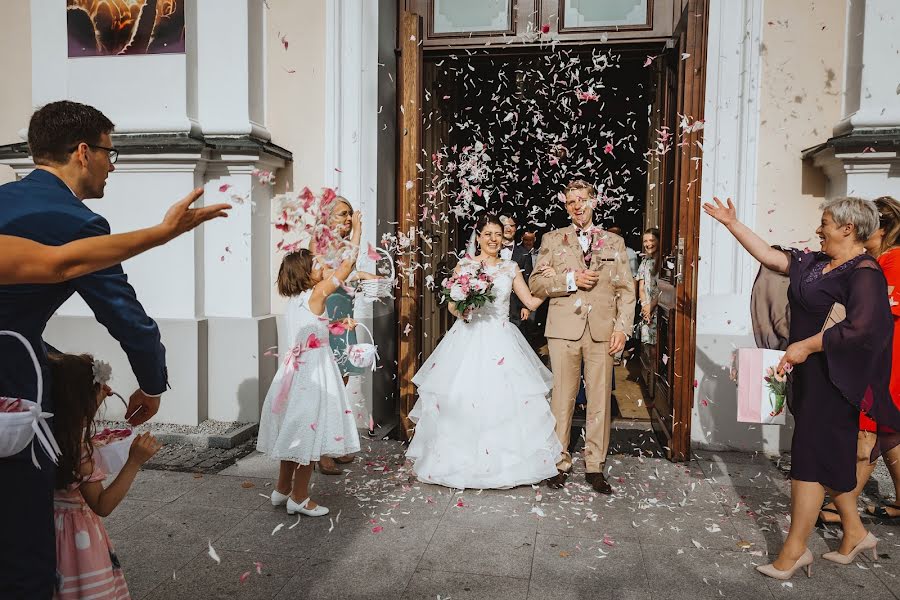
<box><xmin>106</xmin><ymin>433</ymin><xmax>900</xmax><ymax>600</ymax></box>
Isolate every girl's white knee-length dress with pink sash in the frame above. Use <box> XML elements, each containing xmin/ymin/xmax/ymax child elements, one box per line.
<box><xmin>256</xmin><ymin>290</ymin><xmax>359</xmax><ymax>465</ymax></box>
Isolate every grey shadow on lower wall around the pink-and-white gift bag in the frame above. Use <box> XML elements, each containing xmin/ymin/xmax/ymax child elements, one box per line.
<box><xmin>691</xmin><ymin>336</ymin><xmax>794</xmax><ymax>455</ymax></box>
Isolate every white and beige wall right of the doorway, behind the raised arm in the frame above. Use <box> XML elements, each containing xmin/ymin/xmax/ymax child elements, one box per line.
<box><xmin>691</xmin><ymin>0</ymin><xmax>854</xmax><ymax>453</ymax></box>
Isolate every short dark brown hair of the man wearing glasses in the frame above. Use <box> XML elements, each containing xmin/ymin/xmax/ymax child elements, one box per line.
<box><xmin>28</xmin><ymin>100</ymin><xmax>115</xmax><ymax>165</ymax></box>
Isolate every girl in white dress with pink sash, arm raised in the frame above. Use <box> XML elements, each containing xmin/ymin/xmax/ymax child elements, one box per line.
<box><xmin>256</xmin><ymin>212</ymin><xmax>362</xmax><ymax>517</ymax></box>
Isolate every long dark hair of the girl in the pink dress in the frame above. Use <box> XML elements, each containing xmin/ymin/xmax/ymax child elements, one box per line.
<box><xmin>47</xmin><ymin>354</ymin><xmax>100</xmax><ymax>490</ymax></box>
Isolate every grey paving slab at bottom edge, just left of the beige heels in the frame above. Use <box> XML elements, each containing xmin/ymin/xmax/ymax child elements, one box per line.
<box><xmin>641</xmin><ymin>542</ymin><xmax>772</xmax><ymax>599</ymax></box>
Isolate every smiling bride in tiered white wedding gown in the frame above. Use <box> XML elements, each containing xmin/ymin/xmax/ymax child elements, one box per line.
<box><xmin>406</xmin><ymin>215</ymin><xmax>562</xmax><ymax>489</ymax></box>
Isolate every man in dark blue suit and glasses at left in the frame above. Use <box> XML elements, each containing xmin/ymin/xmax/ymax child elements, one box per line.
<box><xmin>0</xmin><ymin>101</ymin><xmax>168</xmax><ymax>598</ymax></box>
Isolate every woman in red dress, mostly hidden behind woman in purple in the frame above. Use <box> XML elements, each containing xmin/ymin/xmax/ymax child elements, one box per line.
<box><xmin>819</xmin><ymin>196</ymin><xmax>900</xmax><ymax>524</ymax></box>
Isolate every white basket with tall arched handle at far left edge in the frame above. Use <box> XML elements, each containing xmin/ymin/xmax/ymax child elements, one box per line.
<box><xmin>0</xmin><ymin>331</ymin><xmax>60</xmax><ymax>469</ymax></box>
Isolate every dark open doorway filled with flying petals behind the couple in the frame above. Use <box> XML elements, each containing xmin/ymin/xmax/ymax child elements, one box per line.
<box><xmin>420</xmin><ymin>46</ymin><xmax>655</xmax><ymax>360</ymax></box>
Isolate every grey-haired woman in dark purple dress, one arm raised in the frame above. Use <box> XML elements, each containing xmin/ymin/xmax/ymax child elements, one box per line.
<box><xmin>703</xmin><ymin>198</ymin><xmax>900</xmax><ymax>579</ymax></box>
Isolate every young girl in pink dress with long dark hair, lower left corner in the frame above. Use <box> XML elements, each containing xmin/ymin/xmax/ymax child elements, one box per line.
<box><xmin>49</xmin><ymin>354</ymin><xmax>160</xmax><ymax>600</ymax></box>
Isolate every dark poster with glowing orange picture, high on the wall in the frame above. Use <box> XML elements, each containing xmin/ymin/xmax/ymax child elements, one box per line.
<box><xmin>66</xmin><ymin>0</ymin><xmax>187</xmax><ymax>58</ymax></box>
